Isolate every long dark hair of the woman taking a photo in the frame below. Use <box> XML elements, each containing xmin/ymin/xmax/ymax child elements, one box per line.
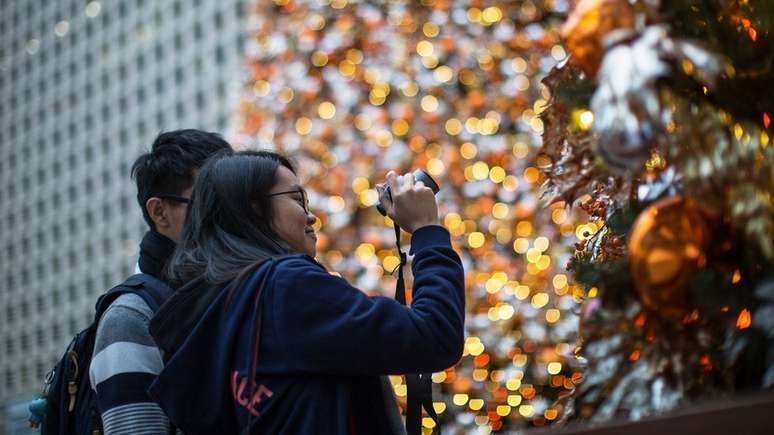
<box><xmin>166</xmin><ymin>151</ymin><xmax>295</xmax><ymax>288</ymax></box>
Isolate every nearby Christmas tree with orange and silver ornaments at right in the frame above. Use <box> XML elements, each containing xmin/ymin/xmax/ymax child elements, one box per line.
<box><xmin>541</xmin><ymin>0</ymin><xmax>774</xmax><ymax>421</ymax></box>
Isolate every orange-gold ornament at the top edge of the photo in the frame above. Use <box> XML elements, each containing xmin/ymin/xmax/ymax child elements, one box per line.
<box><xmin>561</xmin><ymin>0</ymin><xmax>634</xmax><ymax>76</ymax></box>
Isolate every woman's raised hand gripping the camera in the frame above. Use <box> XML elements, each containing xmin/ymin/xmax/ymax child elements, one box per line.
<box><xmin>376</xmin><ymin>171</ymin><xmax>439</xmax><ymax>233</ymax></box>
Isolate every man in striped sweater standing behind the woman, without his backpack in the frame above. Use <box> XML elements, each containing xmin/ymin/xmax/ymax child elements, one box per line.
<box><xmin>89</xmin><ymin>129</ymin><xmax>231</xmax><ymax>435</ymax></box>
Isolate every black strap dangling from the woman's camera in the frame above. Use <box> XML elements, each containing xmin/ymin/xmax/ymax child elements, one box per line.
<box><xmin>393</xmin><ymin>224</ymin><xmax>441</xmax><ymax>435</ymax></box>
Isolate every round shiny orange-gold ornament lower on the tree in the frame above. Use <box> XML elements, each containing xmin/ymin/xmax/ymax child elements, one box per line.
<box><xmin>629</xmin><ymin>195</ymin><xmax>710</xmax><ymax>320</ymax></box>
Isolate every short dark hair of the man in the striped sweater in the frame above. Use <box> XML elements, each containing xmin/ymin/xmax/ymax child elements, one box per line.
<box><xmin>132</xmin><ymin>129</ymin><xmax>231</xmax><ymax>229</ymax></box>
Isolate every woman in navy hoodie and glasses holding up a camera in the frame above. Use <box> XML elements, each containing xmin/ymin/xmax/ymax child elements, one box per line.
<box><xmin>150</xmin><ymin>151</ymin><xmax>464</xmax><ymax>435</ymax></box>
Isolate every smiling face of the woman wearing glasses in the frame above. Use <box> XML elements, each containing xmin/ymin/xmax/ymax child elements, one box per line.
<box><xmin>269</xmin><ymin>166</ymin><xmax>317</xmax><ymax>257</ymax></box>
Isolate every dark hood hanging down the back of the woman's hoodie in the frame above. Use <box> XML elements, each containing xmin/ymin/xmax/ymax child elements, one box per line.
<box><xmin>148</xmin><ymin>261</ymin><xmax>274</xmax><ymax>435</ymax></box>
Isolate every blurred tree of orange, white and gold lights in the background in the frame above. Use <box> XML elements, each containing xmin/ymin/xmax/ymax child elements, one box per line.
<box><xmin>237</xmin><ymin>0</ymin><xmax>584</xmax><ymax>433</ymax></box>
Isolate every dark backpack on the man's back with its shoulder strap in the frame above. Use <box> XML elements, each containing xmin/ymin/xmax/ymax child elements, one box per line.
<box><xmin>30</xmin><ymin>273</ymin><xmax>174</xmax><ymax>435</ymax></box>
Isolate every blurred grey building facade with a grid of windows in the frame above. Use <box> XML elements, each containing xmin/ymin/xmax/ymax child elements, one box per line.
<box><xmin>0</xmin><ymin>0</ymin><xmax>246</xmax><ymax>434</ymax></box>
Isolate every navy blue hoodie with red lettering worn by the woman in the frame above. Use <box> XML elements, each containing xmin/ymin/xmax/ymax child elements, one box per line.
<box><xmin>149</xmin><ymin>226</ymin><xmax>465</xmax><ymax>435</ymax></box>
